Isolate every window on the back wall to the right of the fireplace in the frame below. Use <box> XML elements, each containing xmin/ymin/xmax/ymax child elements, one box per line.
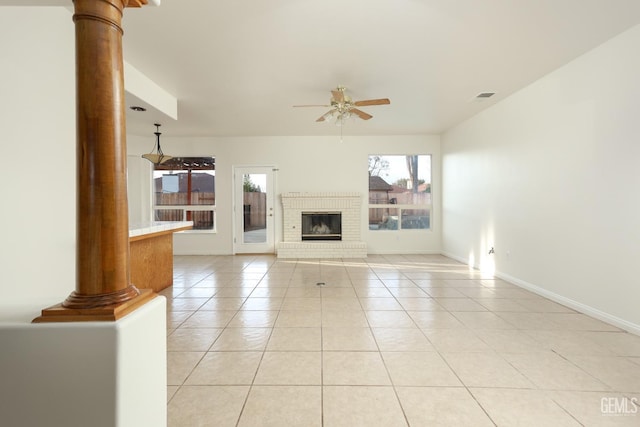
<box><xmin>369</xmin><ymin>154</ymin><xmax>431</xmax><ymax>230</ymax></box>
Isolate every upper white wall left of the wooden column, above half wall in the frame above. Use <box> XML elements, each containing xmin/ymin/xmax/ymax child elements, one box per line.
<box><xmin>0</xmin><ymin>7</ymin><xmax>76</xmax><ymax>310</ymax></box>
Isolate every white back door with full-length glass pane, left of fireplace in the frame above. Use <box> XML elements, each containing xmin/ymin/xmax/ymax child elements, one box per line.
<box><xmin>233</xmin><ymin>166</ymin><xmax>275</xmax><ymax>254</ymax></box>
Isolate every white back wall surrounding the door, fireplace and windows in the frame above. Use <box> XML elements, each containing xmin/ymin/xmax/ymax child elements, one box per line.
<box><xmin>128</xmin><ymin>132</ymin><xmax>440</xmax><ymax>254</ymax></box>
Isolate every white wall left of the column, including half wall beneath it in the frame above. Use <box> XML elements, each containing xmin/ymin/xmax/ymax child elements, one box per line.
<box><xmin>0</xmin><ymin>10</ymin><xmax>166</xmax><ymax>427</ymax></box>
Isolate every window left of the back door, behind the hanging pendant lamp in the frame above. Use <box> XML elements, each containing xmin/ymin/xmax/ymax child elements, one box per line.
<box><xmin>153</xmin><ymin>157</ymin><xmax>216</xmax><ymax>231</ymax></box>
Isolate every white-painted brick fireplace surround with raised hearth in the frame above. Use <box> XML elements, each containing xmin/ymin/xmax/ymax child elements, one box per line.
<box><xmin>278</xmin><ymin>192</ymin><xmax>367</xmax><ymax>258</ymax></box>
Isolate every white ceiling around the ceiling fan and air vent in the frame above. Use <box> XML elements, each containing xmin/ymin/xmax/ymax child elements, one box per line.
<box><xmin>6</xmin><ymin>0</ymin><xmax>640</xmax><ymax>136</ymax></box>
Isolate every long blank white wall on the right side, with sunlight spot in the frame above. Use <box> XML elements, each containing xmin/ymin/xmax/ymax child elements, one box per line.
<box><xmin>442</xmin><ymin>26</ymin><xmax>640</xmax><ymax>332</ymax></box>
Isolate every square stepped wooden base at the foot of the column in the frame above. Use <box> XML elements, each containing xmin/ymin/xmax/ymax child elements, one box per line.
<box><xmin>32</xmin><ymin>289</ymin><xmax>156</xmax><ymax>323</ymax></box>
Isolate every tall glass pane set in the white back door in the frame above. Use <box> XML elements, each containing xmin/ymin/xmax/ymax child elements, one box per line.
<box><xmin>242</xmin><ymin>173</ymin><xmax>267</xmax><ymax>243</ymax></box>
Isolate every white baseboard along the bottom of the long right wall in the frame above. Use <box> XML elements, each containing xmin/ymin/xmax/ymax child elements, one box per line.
<box><xmin>441</xmin><ymin>251</ymin><xmax>640</xmax><ymax>335</ymax></box>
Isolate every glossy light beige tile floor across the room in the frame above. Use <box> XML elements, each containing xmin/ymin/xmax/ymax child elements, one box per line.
<box><xmin>162</xmin><ymin>255</ymin><xmax>640</xmax><ymax>427</ymax></box>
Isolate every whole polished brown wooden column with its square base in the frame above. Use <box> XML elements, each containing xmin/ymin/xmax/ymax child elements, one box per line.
<box><xmin>34</xmin><ymin>0</ymin><xmax>154</xmax><ymax>322</ymax></box>
